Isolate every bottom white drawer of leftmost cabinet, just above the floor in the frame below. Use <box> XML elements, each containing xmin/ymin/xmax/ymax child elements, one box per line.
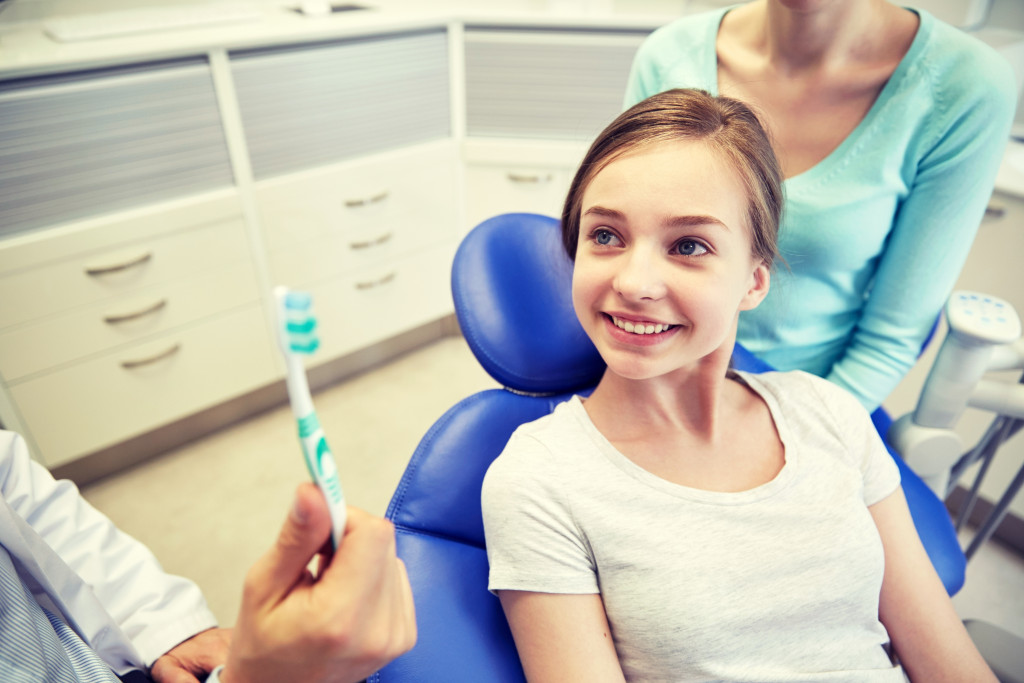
<box><xmin>11</xmin><ymin>305</ymin><xmax>278</xmax><ymax>467</ymax></box>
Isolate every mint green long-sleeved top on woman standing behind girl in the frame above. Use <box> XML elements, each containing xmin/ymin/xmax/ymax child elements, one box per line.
<box><xmin>626</xmin><ymin>7</ymin><xmax>1017</xmax><ymax>410</ymax></box>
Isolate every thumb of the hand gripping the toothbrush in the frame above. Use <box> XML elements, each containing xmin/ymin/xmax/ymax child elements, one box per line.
<box><xmin>247</xmin><ymin>483</ymin><xmax>331</xmax><ymax>602</ymax></box>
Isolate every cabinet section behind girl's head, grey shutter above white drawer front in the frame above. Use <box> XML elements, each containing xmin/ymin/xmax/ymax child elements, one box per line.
<box><xmin>463</xmin><ymin>25</ymin><xmax>648</xmax><ymax>229</ymax></box>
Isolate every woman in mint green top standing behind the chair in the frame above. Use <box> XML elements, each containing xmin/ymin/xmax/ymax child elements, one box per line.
<box><xmin>626</xmin><ymin>0</ymin><xmax>1016</xmax><ymax>410</ymax></box>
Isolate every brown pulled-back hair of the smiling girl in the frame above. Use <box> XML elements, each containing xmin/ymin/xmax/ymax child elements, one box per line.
<box><xmin>562</xmin><ymin>89</ymin><xmax>782</xmax><ymax>267</ymax></box>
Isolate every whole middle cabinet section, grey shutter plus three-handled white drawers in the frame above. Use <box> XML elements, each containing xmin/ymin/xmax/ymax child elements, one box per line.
<box><xmin>231</xmin><ymin>28</ymin><xmax>459</xmax><ymax>374</ymax></box>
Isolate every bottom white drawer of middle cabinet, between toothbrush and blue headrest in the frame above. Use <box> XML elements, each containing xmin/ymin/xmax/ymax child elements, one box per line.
<box><xmin>310</xmin><ymin>244</ymin><xmax>455</xmax><ymax>364</ymax></box>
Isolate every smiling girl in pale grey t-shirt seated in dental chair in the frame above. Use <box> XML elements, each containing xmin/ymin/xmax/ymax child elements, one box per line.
<box><xmin>482</xmin><ymin>90</ymin><xmax>994</xmax><ymax>683</ymax></box>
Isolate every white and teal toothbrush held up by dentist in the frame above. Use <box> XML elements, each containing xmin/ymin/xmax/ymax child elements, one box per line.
<box><xmin>273</xmin><ymin>287</ymin><xmax>345</xmax><ymax>549</ymax></box>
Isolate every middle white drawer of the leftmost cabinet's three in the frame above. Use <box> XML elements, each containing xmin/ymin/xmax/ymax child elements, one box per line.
<box><xmin>0</xmin><ymin>263</ymin><xmax>259</xmax><ymax>383</ymax></box>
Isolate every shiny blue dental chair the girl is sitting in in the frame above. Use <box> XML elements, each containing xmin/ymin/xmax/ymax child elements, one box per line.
<box><xmin>369</xmin><ymin>214</ymin><xmax>966</xmax><ymax>683</ymax></box>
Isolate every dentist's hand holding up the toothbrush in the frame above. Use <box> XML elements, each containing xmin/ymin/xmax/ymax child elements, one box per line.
<box><xmin>220</xmin><ymin>484</ymin><xmax>416</xmax><ymax>683</ymax></box>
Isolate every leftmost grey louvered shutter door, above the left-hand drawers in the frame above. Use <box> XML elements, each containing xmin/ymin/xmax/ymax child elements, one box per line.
<box><xmin>0</xmin><ymin>57</ymin><xmax>233</xmax><ymax>239</ymax></box>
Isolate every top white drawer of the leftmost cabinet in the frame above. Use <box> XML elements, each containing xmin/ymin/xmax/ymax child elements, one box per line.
<box><xmin>0</xmin><ymin>216</ymin><xmax>249</xmax><ymax>328</ymax></box>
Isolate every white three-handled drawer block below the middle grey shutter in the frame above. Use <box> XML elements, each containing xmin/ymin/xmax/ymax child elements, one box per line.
<box><xmin>257</xmin><ymin>140</ymin><xmax>459</xmax><ymax>362</ymax></box>
